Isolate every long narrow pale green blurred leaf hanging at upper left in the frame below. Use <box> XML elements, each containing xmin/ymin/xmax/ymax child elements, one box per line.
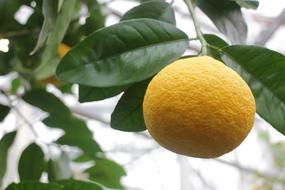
<box><xmin>35</xmin><ymin>0</ymin><xmax>77</xmax><ymax>80</ymax></box>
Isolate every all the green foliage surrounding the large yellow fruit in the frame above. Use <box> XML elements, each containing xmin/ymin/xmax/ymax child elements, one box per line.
<box><xmin>0</xmin><ymin>0</ymin><xmax>285</xmax><ymax>190</ymax></box>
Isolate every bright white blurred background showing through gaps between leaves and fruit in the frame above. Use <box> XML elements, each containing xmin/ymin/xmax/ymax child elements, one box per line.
<box><xmin>0</xmin><ymin>0</ymin><xmax>285</xmax><ymax>190</ymax></box>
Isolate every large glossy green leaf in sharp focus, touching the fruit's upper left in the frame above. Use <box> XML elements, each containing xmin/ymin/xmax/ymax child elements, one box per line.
<box><xmin>57</xmin><ymin>19</ymin><xmax>188</xmax><ymax>87</ymax></box>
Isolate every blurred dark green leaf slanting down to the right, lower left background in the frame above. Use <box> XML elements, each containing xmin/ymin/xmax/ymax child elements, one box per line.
<box><xmin>23</xmin><ymin>90</ymin><xmax>102</xmax><ymax>157</ymax></box>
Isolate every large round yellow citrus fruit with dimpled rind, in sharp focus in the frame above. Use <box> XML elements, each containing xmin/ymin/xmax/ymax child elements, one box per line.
<box><xmin>143</xmin><ymin>56</ymin><xmax>255</xmax><ymax>158</ymax></box>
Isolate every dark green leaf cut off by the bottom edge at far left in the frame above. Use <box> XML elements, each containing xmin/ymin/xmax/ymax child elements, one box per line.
<box><xmin>5</xmin><ymin>181</ymin><xmax>63</xmax><ymax>190</ymax></box>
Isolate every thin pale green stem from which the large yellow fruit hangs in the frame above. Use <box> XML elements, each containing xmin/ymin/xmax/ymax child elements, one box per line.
<box><xmin>184</xmin><ymin>0</ymin><xmax>207</xmax><ymax>55</ymax></box>
